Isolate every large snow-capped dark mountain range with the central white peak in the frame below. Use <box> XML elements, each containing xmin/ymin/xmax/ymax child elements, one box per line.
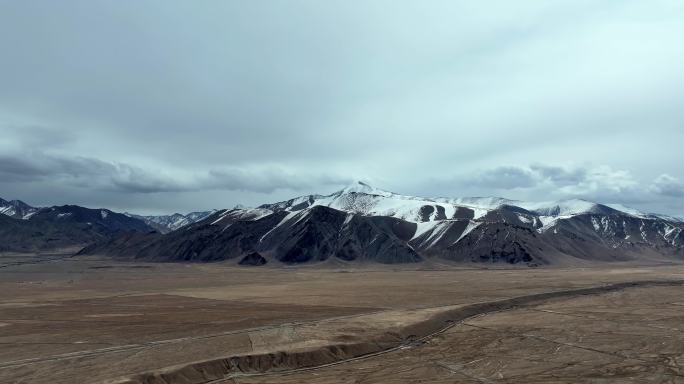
<box><xmin>83</xmin><ymin>183</ymin><xmax>684</xmax><ymax>266</ymax></box>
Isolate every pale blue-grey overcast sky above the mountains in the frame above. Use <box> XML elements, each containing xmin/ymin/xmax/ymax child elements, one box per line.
<box><xmin>0</xmin><ymin>0</ymin><xmax>684</xmax><ymax>215</ymax></box>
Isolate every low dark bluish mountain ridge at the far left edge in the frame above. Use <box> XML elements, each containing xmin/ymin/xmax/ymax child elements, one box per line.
<box><xmin>0</xmin><ymin>205</ymin><xmax>153</xmax><ymax>251</ymax></box>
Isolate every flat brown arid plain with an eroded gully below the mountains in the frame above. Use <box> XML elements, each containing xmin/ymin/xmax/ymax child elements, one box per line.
<box><xmin>0</xmin><ymin>254</ymin><xmax>684</xmax><ymax>384</ymax></box>
